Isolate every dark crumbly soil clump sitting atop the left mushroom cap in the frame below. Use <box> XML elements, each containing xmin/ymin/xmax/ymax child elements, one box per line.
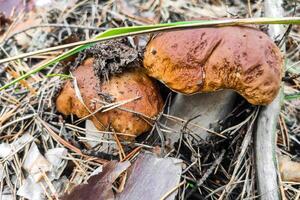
<box><xmin>71</xmin><ymin>39</ymin><xmax>139</xmax><ymax>81</ymax></box>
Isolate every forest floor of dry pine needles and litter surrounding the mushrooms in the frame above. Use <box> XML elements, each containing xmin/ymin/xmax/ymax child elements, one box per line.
<box><xmin>0</xmin><ymin>0</ymin><xmax>300</xmax><ymax>199</ymax></box>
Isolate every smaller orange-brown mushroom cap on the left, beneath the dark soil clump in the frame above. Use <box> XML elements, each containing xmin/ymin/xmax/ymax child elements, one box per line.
<box><xmin>56</xmin><ymin>58</ymin><xmax>163</xmax><ymax>139</ymax></box>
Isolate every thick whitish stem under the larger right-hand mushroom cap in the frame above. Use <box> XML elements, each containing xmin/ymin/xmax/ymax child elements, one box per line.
<box><xmin>166</xmin><ymin>90</ymin><xmax>236</xmax><ymax>144</ymax></box>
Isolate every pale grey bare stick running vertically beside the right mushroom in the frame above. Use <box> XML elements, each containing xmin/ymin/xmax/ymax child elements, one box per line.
<box><xmin>255</xmin><ymin>0</ymin><xmax>283</xmax><ymax>200</ymax></box>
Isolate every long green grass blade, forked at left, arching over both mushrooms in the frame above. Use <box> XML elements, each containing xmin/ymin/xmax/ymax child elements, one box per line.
<box><xmin>0</xmin><ymin>17</ymin><xmax>300</xmax><ymax>91</ymax></box>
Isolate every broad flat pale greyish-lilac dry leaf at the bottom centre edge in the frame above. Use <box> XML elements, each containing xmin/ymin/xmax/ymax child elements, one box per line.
<box><xmin>116</xmin><ymin>153</ymin><xmax>182</xmax><ymax>200</ymax></box>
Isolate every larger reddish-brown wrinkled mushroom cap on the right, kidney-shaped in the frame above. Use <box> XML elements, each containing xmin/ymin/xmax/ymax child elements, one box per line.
<box><xmin>144</xmin><ymin>26</ymin><xmax>283</xmax><ymax>105</ymax></box>
